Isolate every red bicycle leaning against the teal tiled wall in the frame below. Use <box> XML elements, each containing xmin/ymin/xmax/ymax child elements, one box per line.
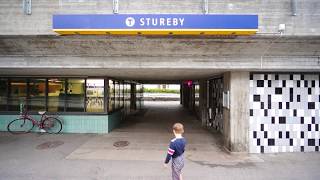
<box><xmin>7</xmin><ymin>105</ymin><xmax>62</xmax><ymax>134</ymax></box>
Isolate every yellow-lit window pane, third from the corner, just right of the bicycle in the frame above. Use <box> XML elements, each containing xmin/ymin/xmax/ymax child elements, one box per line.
<box><xmin>48</xmin><ymin>79</ymin><xmax>66</xmax><ymax>112</ymax></box>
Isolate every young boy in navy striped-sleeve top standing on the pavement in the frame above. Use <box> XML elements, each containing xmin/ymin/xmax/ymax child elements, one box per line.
<box><xmin>164</xmin><ymin>123</ymin><xmax>186</xmax><ymax>180</ymax></box>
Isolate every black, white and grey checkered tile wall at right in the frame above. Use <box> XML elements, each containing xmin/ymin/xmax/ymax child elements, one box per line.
<box><xmin>249</xmin><ymin>74</ymin><xmax>320</xmax><ymax>153</ymax></box>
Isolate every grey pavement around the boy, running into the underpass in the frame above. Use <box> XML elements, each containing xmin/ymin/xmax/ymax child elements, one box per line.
<box><xmin>0</xmin><ymin>102</ymin><xmax>320</xmax><ymax>180</ymax></box>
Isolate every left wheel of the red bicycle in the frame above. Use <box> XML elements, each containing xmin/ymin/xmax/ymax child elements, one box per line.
<box><xmin>7</xmin><ymin>118</ymin><xmax>34</xmax><ymax>134</ymax></box>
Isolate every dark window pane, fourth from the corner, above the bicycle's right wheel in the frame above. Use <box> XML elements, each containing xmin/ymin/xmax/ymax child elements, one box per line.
<box><xmin>28</xmin><ymin>79</ymin><xmax>46</xmax><ymax>111</ymax></box>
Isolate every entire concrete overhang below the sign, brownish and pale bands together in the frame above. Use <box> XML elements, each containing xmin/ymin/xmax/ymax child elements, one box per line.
<box><xmin>0</xmin><ymin>35</ymin><xmax>320</xmax><ymax>80</ymax></box>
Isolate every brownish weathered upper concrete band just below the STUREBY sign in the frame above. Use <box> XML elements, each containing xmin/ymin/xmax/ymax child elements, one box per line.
<box><xmin>0</xmin><ymin>36</ymin><xmax>320</xmax><ymax>58</ymax></box>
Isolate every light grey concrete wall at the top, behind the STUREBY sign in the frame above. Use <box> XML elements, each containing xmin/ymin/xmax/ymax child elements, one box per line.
<box><xmin>0</xmin><ymin>0</ymin><xmax>320</xmax><ymax>35</ymax></box>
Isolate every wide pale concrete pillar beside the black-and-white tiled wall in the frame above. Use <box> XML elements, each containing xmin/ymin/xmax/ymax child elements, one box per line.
<box><xmin>223</xmin><ymin>72</ymin><xmax>250</xmax><ymax>152</ymax></box>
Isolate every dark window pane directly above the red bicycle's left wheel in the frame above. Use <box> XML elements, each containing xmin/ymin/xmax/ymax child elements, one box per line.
<box><xmin>8</xmin><ymin>78</ymin><xmax>27</xmax><ymax>111</ymax></box>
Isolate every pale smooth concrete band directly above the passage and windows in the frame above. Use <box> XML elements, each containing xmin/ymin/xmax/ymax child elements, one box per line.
<box><xmin>0</xmin><ymin>56</ymin><xmax>320</xmax><ymax>70</ymax></box>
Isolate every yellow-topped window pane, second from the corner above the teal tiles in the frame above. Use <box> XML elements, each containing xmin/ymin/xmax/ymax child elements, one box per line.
<box><xmin>66</xmin><ymin>79</ymin><xmax>85</xmax><ymax>112</ymax></box>
